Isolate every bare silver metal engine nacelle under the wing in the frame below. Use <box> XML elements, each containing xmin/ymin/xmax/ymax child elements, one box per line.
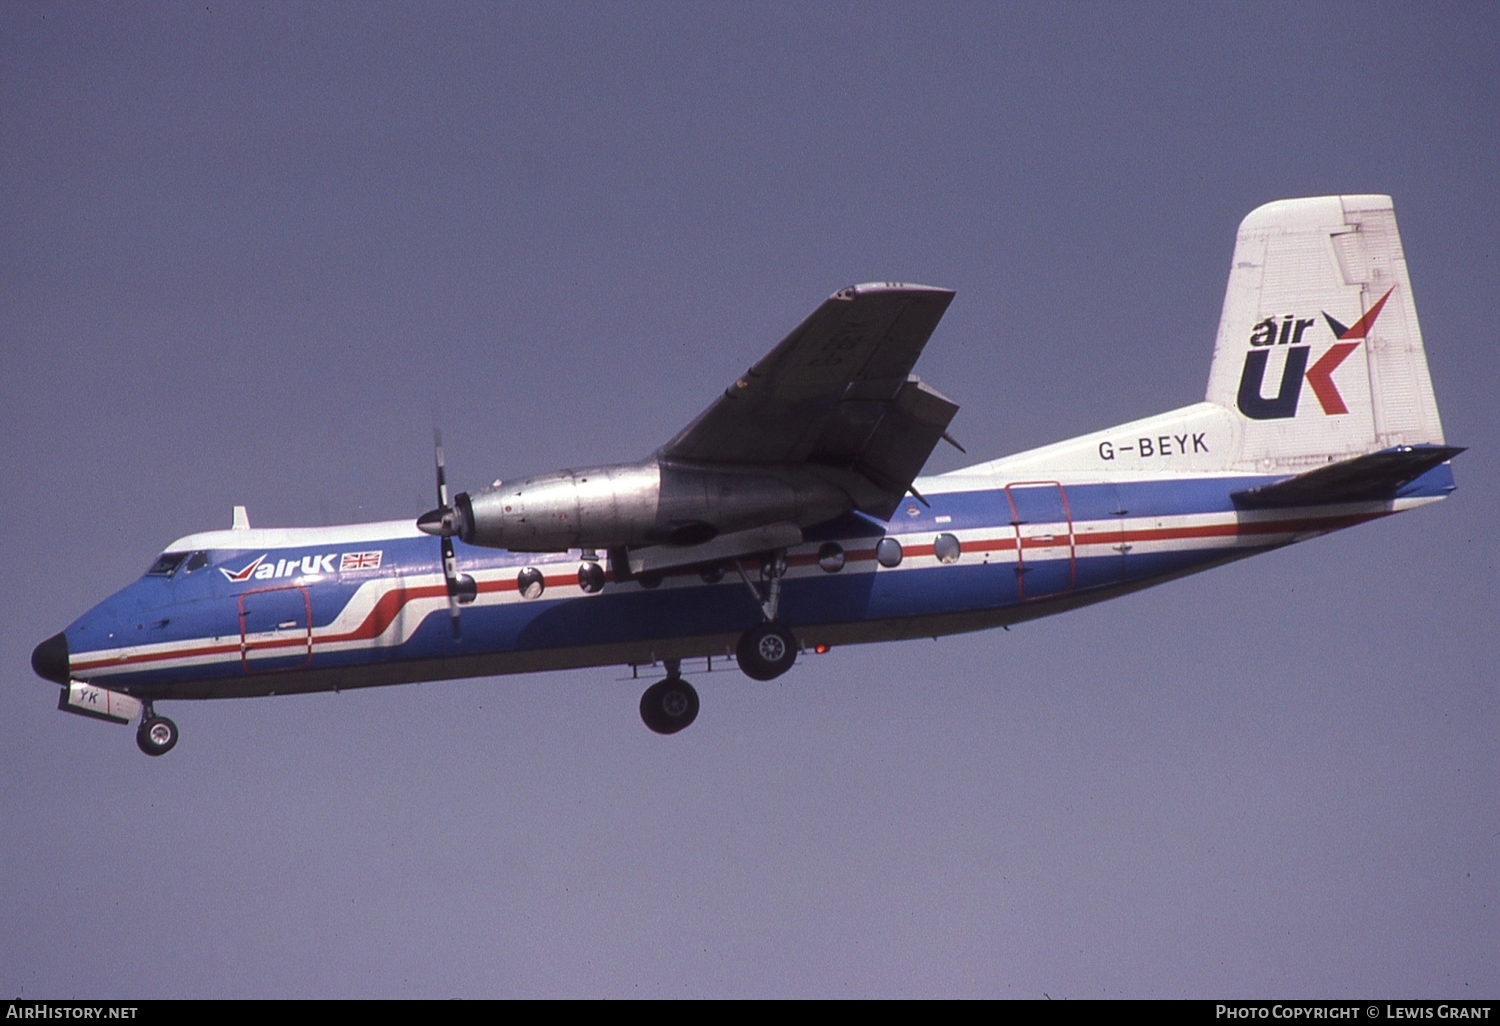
<box><xmin>455</xmin><ymin>459</ymin><xmax>854</xmax><ymax>552</ymax></box>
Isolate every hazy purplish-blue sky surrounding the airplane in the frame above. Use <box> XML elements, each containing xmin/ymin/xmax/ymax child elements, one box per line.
<box><xmin>0</xmin><ymin>0</ymin><xmax>1500</xmax><ymax>998</ymax></box>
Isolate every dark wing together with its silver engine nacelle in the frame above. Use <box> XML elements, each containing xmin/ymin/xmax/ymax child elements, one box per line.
<box><xmin>435</xmin><ymin>285</ymin><xmax>959</xmax><ymax>564</ymax></box>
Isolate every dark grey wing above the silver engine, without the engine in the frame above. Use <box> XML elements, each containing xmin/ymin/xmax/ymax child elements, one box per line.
<box><xmin>660</xmin><ymin>284</ymin><xmax>959</xmax><ymax>518</ymax></box>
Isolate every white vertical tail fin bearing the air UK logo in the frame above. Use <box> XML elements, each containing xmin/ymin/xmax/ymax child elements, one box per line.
<box><xmin>1208</xmin><ymin>197</ymin><xmax>1443</xmax><ymax>468</ymax></box>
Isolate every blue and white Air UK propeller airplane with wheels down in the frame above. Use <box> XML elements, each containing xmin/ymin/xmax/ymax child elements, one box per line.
<box><xmin>32</xmin><ymin>195</ymin><xmax>1463</xmax><ymax>756</ymax></box>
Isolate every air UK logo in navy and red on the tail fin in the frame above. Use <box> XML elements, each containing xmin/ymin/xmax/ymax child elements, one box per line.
<box><xmin>1236</xmin><ymin>287</ymin><xmax>1395</xmax><ymax>420</ymax></box>
